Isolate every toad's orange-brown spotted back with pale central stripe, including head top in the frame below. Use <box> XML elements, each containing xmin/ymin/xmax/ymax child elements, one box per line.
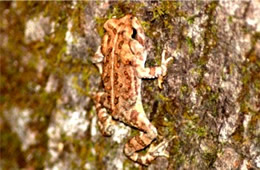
<box><xmin>101</xmin><ymin>15</ymin><xmax>141</xmax><ymax>118</ymax></box>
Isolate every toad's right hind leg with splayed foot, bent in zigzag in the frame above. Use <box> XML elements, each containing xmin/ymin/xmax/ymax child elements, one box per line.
<box><xmin>124</xmin><ymin>109</ymin><xmax>168</xmax><ymax>166</ymax></box>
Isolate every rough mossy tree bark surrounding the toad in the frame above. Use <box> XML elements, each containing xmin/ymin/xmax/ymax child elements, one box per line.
<box><xmin>0</xmin><ymin>0</ymin><xmax>260</xmax><ymax>170</ymax></box>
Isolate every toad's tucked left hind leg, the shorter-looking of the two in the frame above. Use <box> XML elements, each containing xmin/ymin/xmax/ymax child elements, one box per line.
<box><xmin>94</xmin><ymin>92</ymin><xmax>115</xmax><ymax>136</ymax></box>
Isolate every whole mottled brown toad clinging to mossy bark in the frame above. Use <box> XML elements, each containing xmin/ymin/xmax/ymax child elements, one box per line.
<box><xmin>93</xmin><ymin>15</ymin><xmax>171</xmax><ymax>165</ymax></box>
